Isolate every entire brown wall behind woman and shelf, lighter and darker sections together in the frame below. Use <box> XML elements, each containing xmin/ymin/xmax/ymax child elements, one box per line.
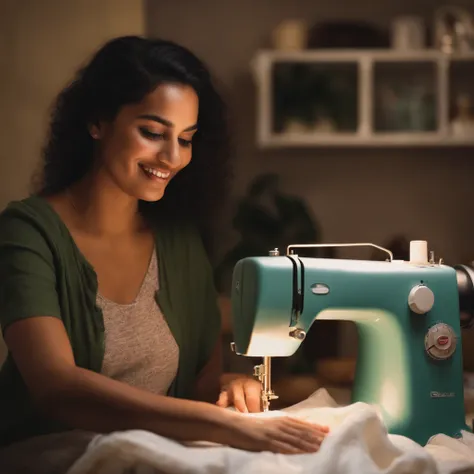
<box><xmin>0</xmin><ymin>0</ymin><xmax>474</xmax><ymax>364</ymax></box>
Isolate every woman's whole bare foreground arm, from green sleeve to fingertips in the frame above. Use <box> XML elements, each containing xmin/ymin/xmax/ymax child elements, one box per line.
<box><xmin>5</xmin><ymin>316</ymin><xmax>328</xmax><ymax>454</ymax></box>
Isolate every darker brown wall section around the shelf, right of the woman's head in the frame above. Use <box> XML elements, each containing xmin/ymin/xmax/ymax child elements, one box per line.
<box><xmin>147</xmin><ymin>0</ymin><xmax>474</xmax><ymax>362</ymax></box>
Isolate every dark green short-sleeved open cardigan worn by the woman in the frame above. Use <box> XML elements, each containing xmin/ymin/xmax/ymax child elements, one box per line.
<box><xmin>0</xmin><ymin>196</ymin><xmax>220</xmax><ymax>446</ymax></box>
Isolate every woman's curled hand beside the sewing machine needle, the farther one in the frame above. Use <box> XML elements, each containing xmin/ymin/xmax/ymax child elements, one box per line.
<box><xmin>217</xmin><ymin>376</ymin><xmax>262</xmax><ymax>413</ymax></box>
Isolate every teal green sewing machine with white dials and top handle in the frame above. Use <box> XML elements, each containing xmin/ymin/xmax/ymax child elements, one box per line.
<box><xmin>232</xmin><ymin>241</ymin><xmax>474</xmax><ymax>444</ymax></box>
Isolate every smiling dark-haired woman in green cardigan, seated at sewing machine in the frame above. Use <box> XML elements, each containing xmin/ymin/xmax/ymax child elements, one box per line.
<box><xmin>0</xmin><ymin>37</ymin><xmax>327</xmax><ymax>472</ymax></box>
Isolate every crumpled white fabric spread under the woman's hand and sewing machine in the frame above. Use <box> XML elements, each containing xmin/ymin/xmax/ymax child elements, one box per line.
<box><xmin>67</xmin><ymin>389</ymin><xmax>474</xmax><ymax>474</ymax></box>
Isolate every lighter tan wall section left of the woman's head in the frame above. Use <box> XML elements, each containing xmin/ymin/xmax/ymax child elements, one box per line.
<box><xmin>0</xmin><ymin>0</ymin><xmax>144</xmax><ymax>361</ymax></box>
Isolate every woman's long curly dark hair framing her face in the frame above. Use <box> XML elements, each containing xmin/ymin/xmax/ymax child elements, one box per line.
<box><xmin>33</xmin><ymin>36</ymin><xmax>230</xmax><ymax>252</ymax></box>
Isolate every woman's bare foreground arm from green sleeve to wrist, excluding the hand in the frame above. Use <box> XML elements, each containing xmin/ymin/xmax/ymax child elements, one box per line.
<box><xmin>5</xmin><ymin>317</ymin><xmax>235</xmax><ymax>443</ymax></box>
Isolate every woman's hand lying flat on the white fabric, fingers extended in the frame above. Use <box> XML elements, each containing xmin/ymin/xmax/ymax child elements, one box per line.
<box><xmin>224</xmin><ymin>415</ymin><xmax>329</xmax><ymax>454</ymax></box>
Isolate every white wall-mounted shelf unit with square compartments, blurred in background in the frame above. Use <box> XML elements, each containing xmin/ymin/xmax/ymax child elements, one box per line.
<box><xmin>252</xmin><ymin>50</ymin><xmax>474</xmax><ymax>148</ymax></box>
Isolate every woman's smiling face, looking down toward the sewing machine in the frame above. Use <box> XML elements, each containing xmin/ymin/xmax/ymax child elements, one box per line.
<box><xmin>92</xmin><ymin>84</ymin><xmax>199</xmax><ymax>201</ymax></box>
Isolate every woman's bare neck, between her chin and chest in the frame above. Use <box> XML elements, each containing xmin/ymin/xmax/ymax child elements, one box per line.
<box><xmin>67</xmin><ymin>171</ymin><xmax>144</xmax><ymax>237</ymax></box>
